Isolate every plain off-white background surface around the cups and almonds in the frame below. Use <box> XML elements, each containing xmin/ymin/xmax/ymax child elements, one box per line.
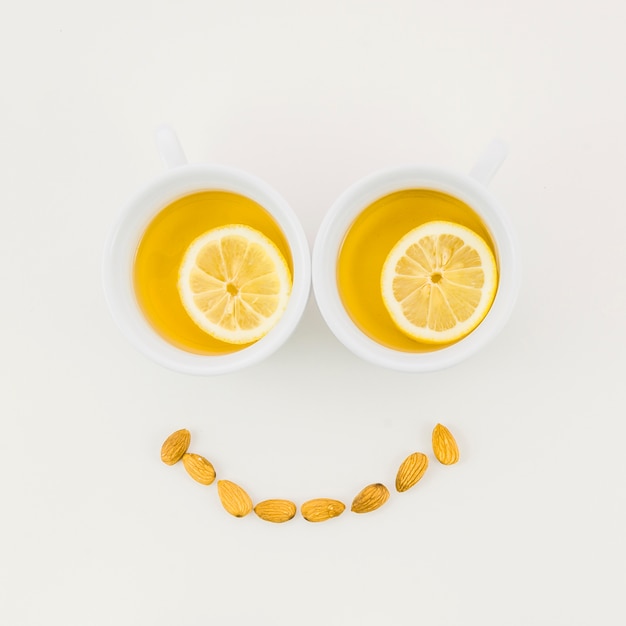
<box><xmin>0</xmin><ymin>0</ymin><xmax>626</xmax><ymax>626</ymax></box>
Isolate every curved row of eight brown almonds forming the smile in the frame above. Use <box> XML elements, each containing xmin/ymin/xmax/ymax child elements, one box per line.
<box><xmin>161</xmin><ymin>424</ymin><xmax>459</xmax><ymax>523</ymax></box>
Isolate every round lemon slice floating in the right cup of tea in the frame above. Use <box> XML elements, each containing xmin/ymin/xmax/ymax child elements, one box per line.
<box><xmin>381</xmin><ymin>221</ymin><xmax>498</xmax><ymax>344</ymax></box>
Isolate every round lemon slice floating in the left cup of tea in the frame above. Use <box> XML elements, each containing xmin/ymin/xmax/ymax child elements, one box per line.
<box><xmin>178</xmin><ymin>224</ymin><xmax>291</xmax><ymax>344</ymax></box>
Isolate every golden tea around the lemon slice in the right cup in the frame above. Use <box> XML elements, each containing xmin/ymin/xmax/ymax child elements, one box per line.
<box><xmin>337</xmin><ymin>189</ymin><xmax>497</xmax><ymax>352</ymax></box>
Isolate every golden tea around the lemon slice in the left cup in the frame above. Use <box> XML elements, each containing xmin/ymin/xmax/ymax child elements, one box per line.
<box><xmin>134</xmin><ymin>191</ymin><xmax>293</xmax><ymax>355</ymax></box>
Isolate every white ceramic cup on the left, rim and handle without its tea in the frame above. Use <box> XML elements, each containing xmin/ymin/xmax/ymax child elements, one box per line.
<box><xmin>102</xmin><ymin>126</ymin><xmax>311</xmax><ymax>375</ymax></box>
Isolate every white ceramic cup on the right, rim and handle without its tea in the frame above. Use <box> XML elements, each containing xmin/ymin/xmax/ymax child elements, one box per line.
<box><xmin>312</xmin><ymin>140</ymin><xmax>521</xmax><ymax>372</ymax></box>
